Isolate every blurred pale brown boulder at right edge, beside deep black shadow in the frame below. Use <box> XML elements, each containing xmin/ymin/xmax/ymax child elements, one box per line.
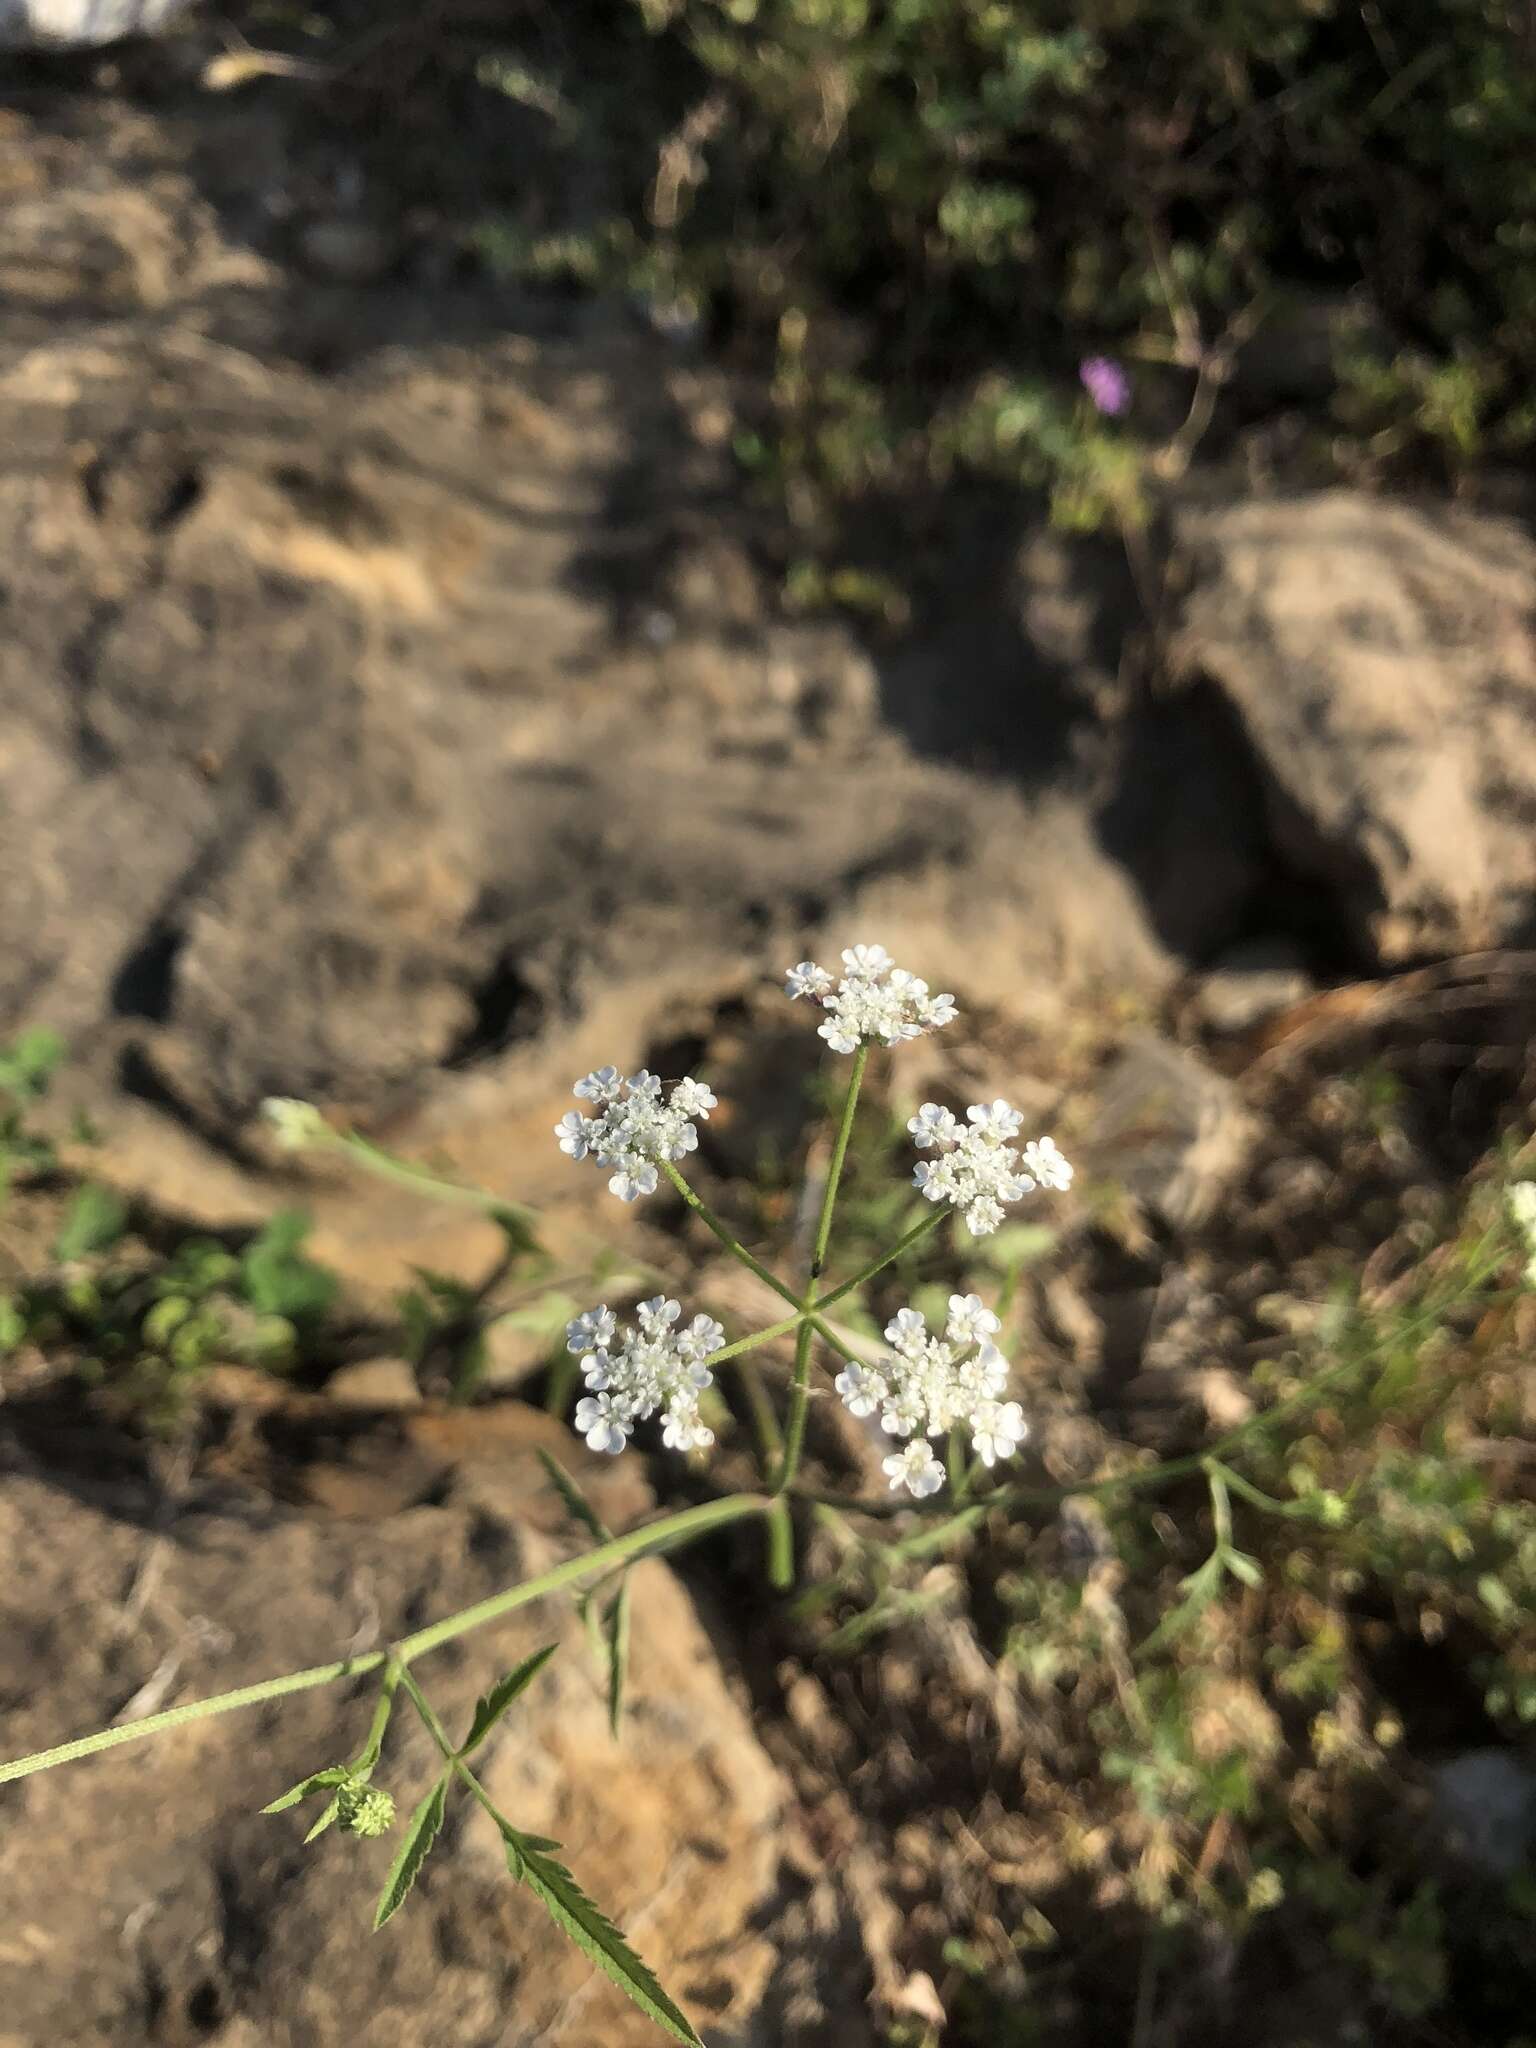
<box><xmin>1176</xmin><ymin>489</ymin><xmax>1536</xmax><ymax>965</ymax></box>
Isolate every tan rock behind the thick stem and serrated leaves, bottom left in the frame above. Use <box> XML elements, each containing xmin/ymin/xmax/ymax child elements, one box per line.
<box><xmin>0</xmin><ymin>1415</ymin><xmax>782</xmax><ymax>2048</ymax></box>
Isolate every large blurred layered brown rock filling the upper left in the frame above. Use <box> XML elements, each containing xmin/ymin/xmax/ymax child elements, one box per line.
<box><xmin>0</xmin><ymin>72</ymin><xmax>1225</xmax><ymax>1236</ymax></box>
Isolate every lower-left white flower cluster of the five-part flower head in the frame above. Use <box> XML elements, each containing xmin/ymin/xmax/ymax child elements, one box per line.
<box><xmin>565</xmin><ymin>1294</ymin><xmax>725</xmax><ymax>1452</ymax></box>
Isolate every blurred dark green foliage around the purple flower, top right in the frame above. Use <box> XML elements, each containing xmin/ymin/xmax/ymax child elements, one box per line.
<box><xmin>475</xmin><ymin>0</ymin><xmax>1536</xmax><ymax>577</ymax></box>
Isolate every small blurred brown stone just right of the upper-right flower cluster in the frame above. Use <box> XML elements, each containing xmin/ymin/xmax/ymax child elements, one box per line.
<box><xmin>1083</xmin><ymin>1034</ymin><xmax>1257</xmax><ymax>1229</ymax></box>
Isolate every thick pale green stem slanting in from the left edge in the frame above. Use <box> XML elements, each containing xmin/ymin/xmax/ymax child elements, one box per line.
<box><xmin>0</xmin><ymin>1493</ymin><xmax>772</xmax><ymax>1784</ymax></box>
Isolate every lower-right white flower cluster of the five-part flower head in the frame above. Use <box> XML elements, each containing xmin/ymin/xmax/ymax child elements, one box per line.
<box><xmin>836</xmin><ymin>1294</ymin><xmax>1028</xmax><ymax>1499</ymax></box>
